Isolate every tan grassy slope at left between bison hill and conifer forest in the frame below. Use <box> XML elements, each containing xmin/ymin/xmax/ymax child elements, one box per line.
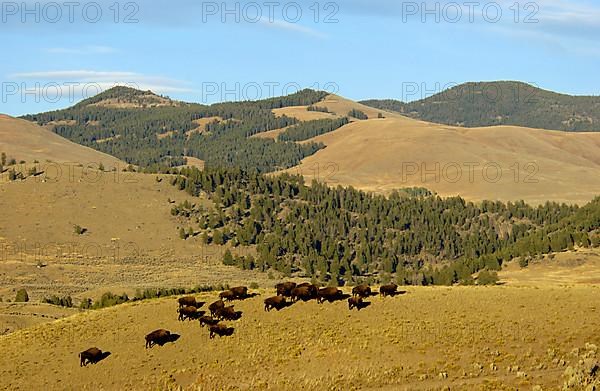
<box><xmin>0</xmin><ymin>167</ymin><xmax>271</xmax><ymax>310</ymax></box>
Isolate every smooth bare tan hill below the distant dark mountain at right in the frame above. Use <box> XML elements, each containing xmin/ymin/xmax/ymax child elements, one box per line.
<box><xmin>282</xmin><ymin>117</ymin><xmax>600</xmax><ymax>204</ymax></box>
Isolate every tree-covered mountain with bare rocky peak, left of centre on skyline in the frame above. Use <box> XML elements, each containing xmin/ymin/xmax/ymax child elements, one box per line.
<box><xmin>24</xmin><ymin>87</ymin><xmax>327</xmax><ymax>172</ymax></box>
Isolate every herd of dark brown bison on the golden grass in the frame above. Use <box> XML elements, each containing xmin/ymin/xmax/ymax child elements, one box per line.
<box><xmin>79</xmin><ymin>282</ymin><xmax>401</xmax><ymax>367</ymax></box>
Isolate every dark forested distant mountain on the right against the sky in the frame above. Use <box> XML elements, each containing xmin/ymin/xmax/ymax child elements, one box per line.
<box><xmin>361</xmin><ymin>81</ymin><xmax>600</xmax><ymax>132</ymax></box>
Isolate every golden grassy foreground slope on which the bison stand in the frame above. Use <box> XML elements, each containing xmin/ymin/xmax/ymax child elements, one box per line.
<box><xmin>0</xmin><ymin>286</ymin><xmax>600</xmax><ymax>390</ymax></box>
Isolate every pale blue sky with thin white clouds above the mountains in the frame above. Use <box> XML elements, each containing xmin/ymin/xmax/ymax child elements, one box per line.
<box><xmin>0</xmin><ymin>0</ymin><xmax>600</xmax><ymax>115</ymax></box>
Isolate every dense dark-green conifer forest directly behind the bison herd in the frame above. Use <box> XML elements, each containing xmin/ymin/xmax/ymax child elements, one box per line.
<box><xmin>164</xmin><ymin>169</ymin><xmax>600</xmax><ymax>284</ymax></box>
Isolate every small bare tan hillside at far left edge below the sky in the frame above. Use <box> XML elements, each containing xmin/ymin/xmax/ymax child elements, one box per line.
<box><xmin>0</xmin><ymin>115</ymin><xmax>126</xmax><ymax>169</ymax></box>
